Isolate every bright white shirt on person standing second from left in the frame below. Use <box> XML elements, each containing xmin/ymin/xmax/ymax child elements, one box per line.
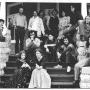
<box><xmin>28</xmin><ymin>16</ymin><xmax>45</xmax><ymax>37</ymax></box>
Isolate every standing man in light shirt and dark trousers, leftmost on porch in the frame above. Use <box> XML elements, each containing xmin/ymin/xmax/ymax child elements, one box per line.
<box><xmin>15</xmin><ymin>8</ymin><xmax>27</xmax><ymax>53</ymax></box>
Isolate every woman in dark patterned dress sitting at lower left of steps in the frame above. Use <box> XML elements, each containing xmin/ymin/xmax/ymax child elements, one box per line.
<box><xmin>8</xmin><ymin>51</ymin><xmax>32</xmax><ymax>88</ymax></box>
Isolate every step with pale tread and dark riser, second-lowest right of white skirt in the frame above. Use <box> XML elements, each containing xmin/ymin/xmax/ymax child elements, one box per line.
<box><xmin>50</xmin><ymin>74</ymin><xmax>74</xmax><ymax>82</ymax></box>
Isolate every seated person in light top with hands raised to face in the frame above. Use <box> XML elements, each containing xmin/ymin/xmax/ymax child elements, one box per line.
<box><xmin>26</xmin><ymin>31</ymin><xmax>41</xmax><ymax>61</ymax></box>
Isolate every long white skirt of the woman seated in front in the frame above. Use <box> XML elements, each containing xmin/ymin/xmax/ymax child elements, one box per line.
<box><xmin>29</xmin><ymin>69</ymin><xmax>51</xmax><ymax>88</ymax></box>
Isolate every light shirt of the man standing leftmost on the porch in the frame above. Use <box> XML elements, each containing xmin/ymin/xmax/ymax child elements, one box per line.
<box><xmin>15</xmin><ymin>13</ymin><xmax>27</xmax><ymax>28</ymax></box>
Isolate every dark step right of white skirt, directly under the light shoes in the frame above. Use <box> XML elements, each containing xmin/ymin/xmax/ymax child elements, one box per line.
<box><xmin>46</xmin><ymin>67</ymin><xmax>74</xmax><ymax>74</ymax></box>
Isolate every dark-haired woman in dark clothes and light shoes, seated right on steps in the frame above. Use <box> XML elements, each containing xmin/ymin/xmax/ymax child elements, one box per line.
<box><xmin>55</xmin><ymin>37</ymin><xmax>76</xmax><ymax>72</ymax></box>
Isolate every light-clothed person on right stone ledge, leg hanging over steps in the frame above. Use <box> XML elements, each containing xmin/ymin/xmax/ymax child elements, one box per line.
<box><xmin>74</xmin><ymin>35</ymin><xmax>90</xmax><ymax>86</ymax></box>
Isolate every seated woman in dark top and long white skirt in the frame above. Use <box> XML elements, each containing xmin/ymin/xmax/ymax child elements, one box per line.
<box><xmin>29</xmin><ymin>49</ymin><xmax>51</xmax><ymax>88</ymax></box>
